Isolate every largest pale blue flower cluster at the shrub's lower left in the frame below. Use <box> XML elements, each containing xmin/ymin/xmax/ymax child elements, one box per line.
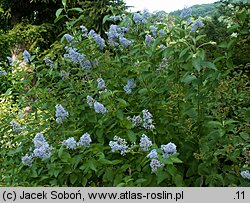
<box><xmin>33</xmin><ymin>133</ymin><xmax>52</xmax><ymax>158</ymax></box>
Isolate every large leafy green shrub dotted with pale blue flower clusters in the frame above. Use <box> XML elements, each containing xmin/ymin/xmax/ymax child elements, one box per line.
<box><xmin>0</xmin><ymin>0</ymin><xmax>250</xmax><ymax>187</ymax></box>
